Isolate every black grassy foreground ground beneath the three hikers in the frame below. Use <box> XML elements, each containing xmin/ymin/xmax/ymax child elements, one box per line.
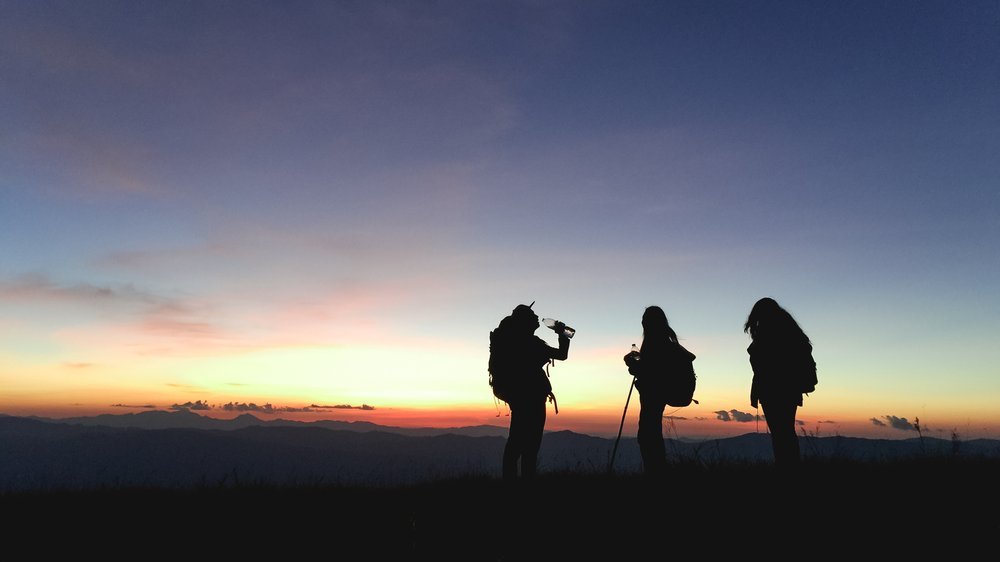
<box><xmin>0</xmin><ymin>459</ymin><xmax>1000</xmax><ymax>560</ymax></box>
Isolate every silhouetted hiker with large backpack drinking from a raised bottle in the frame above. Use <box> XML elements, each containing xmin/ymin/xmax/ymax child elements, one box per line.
<box><xmin>489</xmin><ymin>303</ymin><xmax>569</xmax><ymax>481</ymax></box>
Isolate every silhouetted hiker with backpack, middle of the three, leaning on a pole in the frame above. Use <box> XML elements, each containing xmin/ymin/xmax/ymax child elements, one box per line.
<box><xmin>625</xmin><ymin>306</ymin><xmax>694</xmax><ymax>475</ymax></box>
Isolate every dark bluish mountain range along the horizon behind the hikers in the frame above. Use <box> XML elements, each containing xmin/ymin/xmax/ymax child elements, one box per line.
<box><xmin>0</xmin><ymin>412</ymin><xmax>1000</xmax><ymax>491</ymax></box>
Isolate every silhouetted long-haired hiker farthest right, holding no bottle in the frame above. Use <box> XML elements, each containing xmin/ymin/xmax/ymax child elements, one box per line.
<box><xmin>743</xmin><ymin>298</ymin><xmax>816</xmax><ymax>468</ymax></box>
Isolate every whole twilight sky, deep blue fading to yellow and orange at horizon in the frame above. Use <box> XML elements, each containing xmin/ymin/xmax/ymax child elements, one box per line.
<box><xmin>0</xmin><ymin>0</ymin><xmax>1000</xmax><ymax>438</ymax></box>
